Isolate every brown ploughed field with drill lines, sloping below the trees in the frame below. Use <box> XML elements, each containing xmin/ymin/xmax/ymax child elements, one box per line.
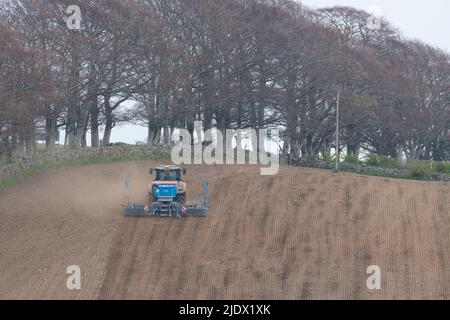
<box><xmin>0</xmin><ymin>162</ymin><xmax>450</xmax><ymax>299</ymax></box>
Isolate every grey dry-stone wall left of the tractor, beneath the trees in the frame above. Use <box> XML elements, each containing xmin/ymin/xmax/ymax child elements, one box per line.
<box><xmin>0</xmin><ymin>145</ymin><xmax>171</xmax><ymax>180</ymax></box>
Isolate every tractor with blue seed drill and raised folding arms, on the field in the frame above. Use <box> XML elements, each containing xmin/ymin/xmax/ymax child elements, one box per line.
<box><xmin>124</xmin><ymin>166</ymin><xmax>211</xmax><ymax>218</ymax></box>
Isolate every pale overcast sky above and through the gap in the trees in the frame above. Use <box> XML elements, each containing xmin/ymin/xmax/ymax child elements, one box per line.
<box><xmin>67</xmin><ymin>0</ymin><xmax>450</xmax><ymax>144</ymax></box>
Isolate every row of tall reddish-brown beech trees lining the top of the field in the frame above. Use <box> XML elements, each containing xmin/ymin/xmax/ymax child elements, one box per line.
<box><xmin>0</xmin><ymin>0</ymin><xmax>450</xmax><ymax>160</ymax></box>
